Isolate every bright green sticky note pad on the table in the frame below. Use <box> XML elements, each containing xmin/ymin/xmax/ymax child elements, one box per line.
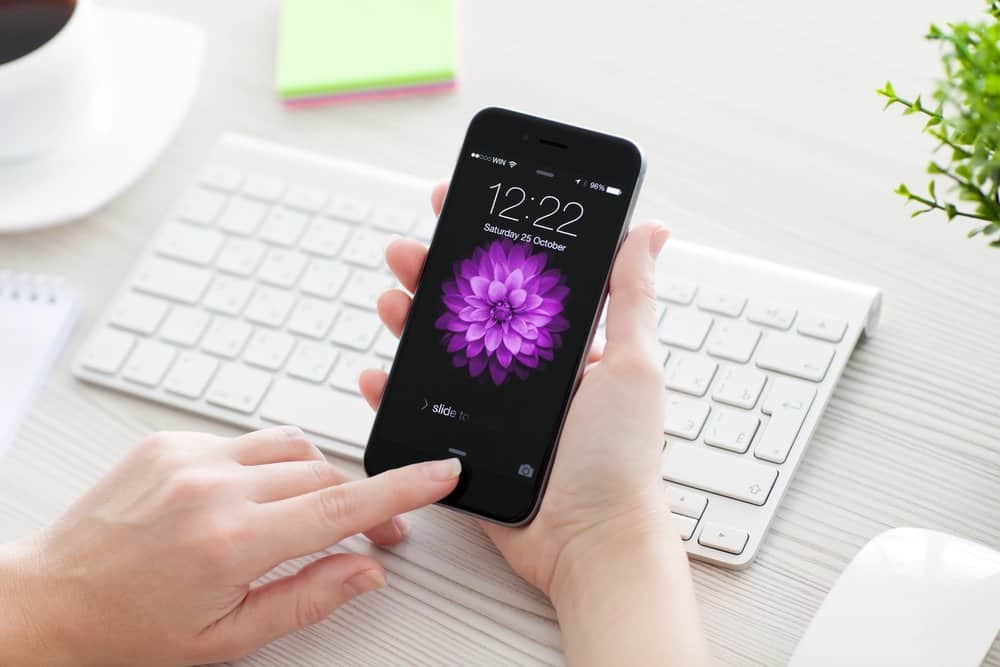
<box><xmin>277</xmin><ymin>0</ymin><xmax>456</xmax><ymax>103</ymax></box>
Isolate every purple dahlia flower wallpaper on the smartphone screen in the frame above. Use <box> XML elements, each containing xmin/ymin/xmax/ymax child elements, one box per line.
<box><xmin>434</xmin><ymin>239</ymin><xmax>569</xmax><ymax>386</ymax></box>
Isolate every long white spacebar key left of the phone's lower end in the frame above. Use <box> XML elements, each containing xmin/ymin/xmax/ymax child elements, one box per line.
<box><xmin>260</xmin><ymin>378</ymin><xmax>374</xmax><ymax>447</ymax></box>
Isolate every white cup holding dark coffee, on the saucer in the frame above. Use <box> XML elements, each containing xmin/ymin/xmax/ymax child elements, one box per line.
<box><xmin>0</xmin><ymin>0</ymin><xmax>98</xmax><ymax>161</ymax></box>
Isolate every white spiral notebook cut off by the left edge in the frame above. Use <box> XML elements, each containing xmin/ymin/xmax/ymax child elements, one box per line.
<box><xmin>0</xmin><ymin>270</ymin><xmax>77</xmax><ymax>456</ymax></box>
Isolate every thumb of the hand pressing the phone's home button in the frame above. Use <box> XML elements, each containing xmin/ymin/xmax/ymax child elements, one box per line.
<box><xmin>201</xmin><ymin>553</ymin><xmax>385</xmax><ymax>662</ymax></box>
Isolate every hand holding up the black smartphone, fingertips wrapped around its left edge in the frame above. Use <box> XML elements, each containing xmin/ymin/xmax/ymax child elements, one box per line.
<box><xmin>361</xmin><ymin>185</ymin><xmax>707</xmax><ymax>664</ymax></box>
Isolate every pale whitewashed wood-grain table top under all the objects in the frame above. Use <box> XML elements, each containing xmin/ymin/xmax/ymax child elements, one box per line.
<box><xmin>0</xmin><ymin>0</ymin><xmax>1000</xmax><ymax>665</ymax></box>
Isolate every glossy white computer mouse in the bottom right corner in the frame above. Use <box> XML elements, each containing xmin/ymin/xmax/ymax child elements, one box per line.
<box><xmin>789</xmin><ymin>528</ymin><xmax>1000</xmax><ymax>667</ymax></box>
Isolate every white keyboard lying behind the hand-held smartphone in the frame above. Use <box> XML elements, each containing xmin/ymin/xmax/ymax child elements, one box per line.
<box><xmin>74</xmin><ymin>135</ymin><xmax>879</xmax><ymax>567</ymax></box>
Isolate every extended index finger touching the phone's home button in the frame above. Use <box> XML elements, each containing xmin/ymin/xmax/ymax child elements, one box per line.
<box><xmin>257</xmin><ymin>458</ymin><xmax>462</xmax><ymax>562</ymax></box>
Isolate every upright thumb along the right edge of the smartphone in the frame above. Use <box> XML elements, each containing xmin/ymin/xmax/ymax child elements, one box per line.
<box><xmin>604</xmin><ymin>223</ymin><xmax>668</xmax><ymax>358</ymax></box>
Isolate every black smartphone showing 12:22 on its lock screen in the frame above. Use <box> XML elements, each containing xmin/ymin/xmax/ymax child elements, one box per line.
<box><xmin>364</xmin><ymin>108</ymin><xmax>644</xmax><ymax>525</ymax></box>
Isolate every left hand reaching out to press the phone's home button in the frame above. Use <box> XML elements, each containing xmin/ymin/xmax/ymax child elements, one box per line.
<box><xmin>0</xmin><ymin>427</ymin><xmax>460</xmax><ymax>665</ymax></box>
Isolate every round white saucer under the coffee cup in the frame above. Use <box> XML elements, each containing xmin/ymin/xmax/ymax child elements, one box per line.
<box><xmin>0</xmin><ymin>7</ymin><xmax>204</xmax><ymax>233</ymax></box>
